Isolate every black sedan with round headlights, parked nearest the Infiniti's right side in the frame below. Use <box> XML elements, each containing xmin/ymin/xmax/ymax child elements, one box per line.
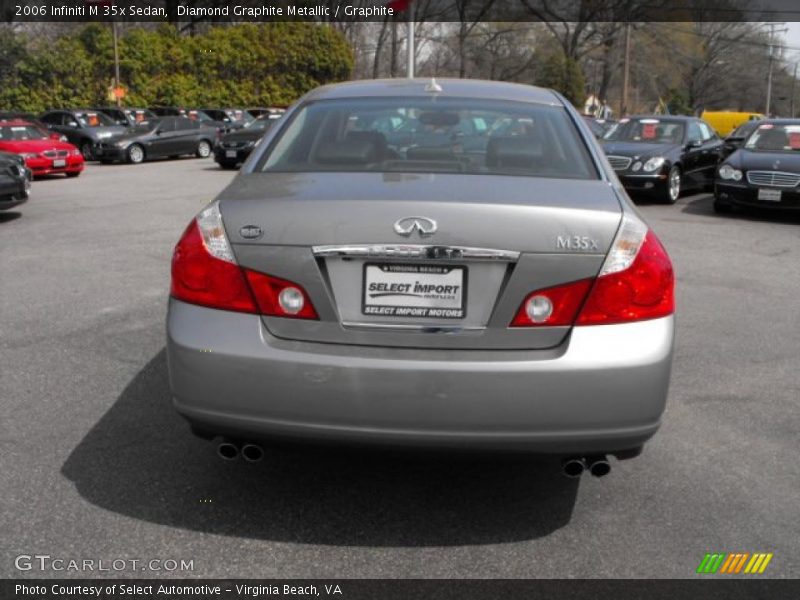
<box><xmin>603</xmin><ymin>115</ymin><xmax>723</xmax><ymax>204</ymax></box>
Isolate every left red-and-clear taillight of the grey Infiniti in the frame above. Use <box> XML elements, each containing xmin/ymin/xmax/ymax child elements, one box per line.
<box><xmin>170</xmin><ymin>203</ymin><xmax>318</xmax><ymax>319</ymax></box>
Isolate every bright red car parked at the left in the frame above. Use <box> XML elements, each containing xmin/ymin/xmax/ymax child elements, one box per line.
<box><xmin>0</xmin><ymin>120</ymin><xmax>84</xmax><ymax>177</ymax></box>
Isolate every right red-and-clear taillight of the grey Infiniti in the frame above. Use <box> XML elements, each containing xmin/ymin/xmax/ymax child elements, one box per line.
<box><xmin>510</xmin><ymin>217</ymin><xmax>675</xmax><ymax>327</ymax></box>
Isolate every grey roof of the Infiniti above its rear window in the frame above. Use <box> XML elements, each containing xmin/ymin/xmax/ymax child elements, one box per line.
<box><xmin>305</xmin><ymin>78</ymin><xmax>564</xmax><ymax>106</ymax></box>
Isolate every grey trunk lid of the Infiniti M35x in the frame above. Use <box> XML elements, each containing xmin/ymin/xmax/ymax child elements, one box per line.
<box><xmin>220</xmin><ymin>173</ymin><xmax>621</xmax><ymax>349</ymax></box>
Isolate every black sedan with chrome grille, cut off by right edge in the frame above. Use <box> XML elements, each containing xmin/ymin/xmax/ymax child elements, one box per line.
<box><xmin>714</xmin><ymin>119</ymin><xmax>800</xmax><ymax>212</ymax></box>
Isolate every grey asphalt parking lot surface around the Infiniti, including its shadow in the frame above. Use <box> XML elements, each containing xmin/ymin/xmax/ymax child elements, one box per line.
<box><xmin>0</xmin><ymin>159</ymin><xmax>800</xmax><ymax>578</ymax></box>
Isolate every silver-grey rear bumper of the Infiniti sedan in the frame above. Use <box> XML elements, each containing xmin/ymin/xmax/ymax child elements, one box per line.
<box><xmin>167</xmin><ymin>299</ymin><xmax>673</xmax><ymax>453</ymax></box>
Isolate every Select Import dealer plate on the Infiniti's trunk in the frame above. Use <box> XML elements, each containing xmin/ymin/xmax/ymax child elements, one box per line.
<box><xmin>361</xmin><ymin>264</ymin><xmax>467</xmax><ymax>319</ymax></box>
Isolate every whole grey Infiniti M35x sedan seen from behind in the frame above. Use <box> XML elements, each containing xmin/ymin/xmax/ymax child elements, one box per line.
<box><xmin>167</xmin><ymin>80</ymin><xmax>674</xmax><ymax>475</ymax></box>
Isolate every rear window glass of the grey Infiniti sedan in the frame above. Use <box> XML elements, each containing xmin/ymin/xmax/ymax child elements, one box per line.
<box><xmin>256</xmin><ymin>97</ymin><xmax>598</xmax><ymax>179</ymax></box>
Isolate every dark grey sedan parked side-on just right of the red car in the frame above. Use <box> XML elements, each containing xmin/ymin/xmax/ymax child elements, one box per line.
<box><xmin>96</xmin><ymin>117</ymin><xmax>216</xmax><ymax>164</ymax></box>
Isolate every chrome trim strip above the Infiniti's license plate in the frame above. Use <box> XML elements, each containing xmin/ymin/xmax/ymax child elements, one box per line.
<box><xmin>311</xmin><ymin>244</ymin><xmax>519</xmax><ymax>262</ymax></box>
